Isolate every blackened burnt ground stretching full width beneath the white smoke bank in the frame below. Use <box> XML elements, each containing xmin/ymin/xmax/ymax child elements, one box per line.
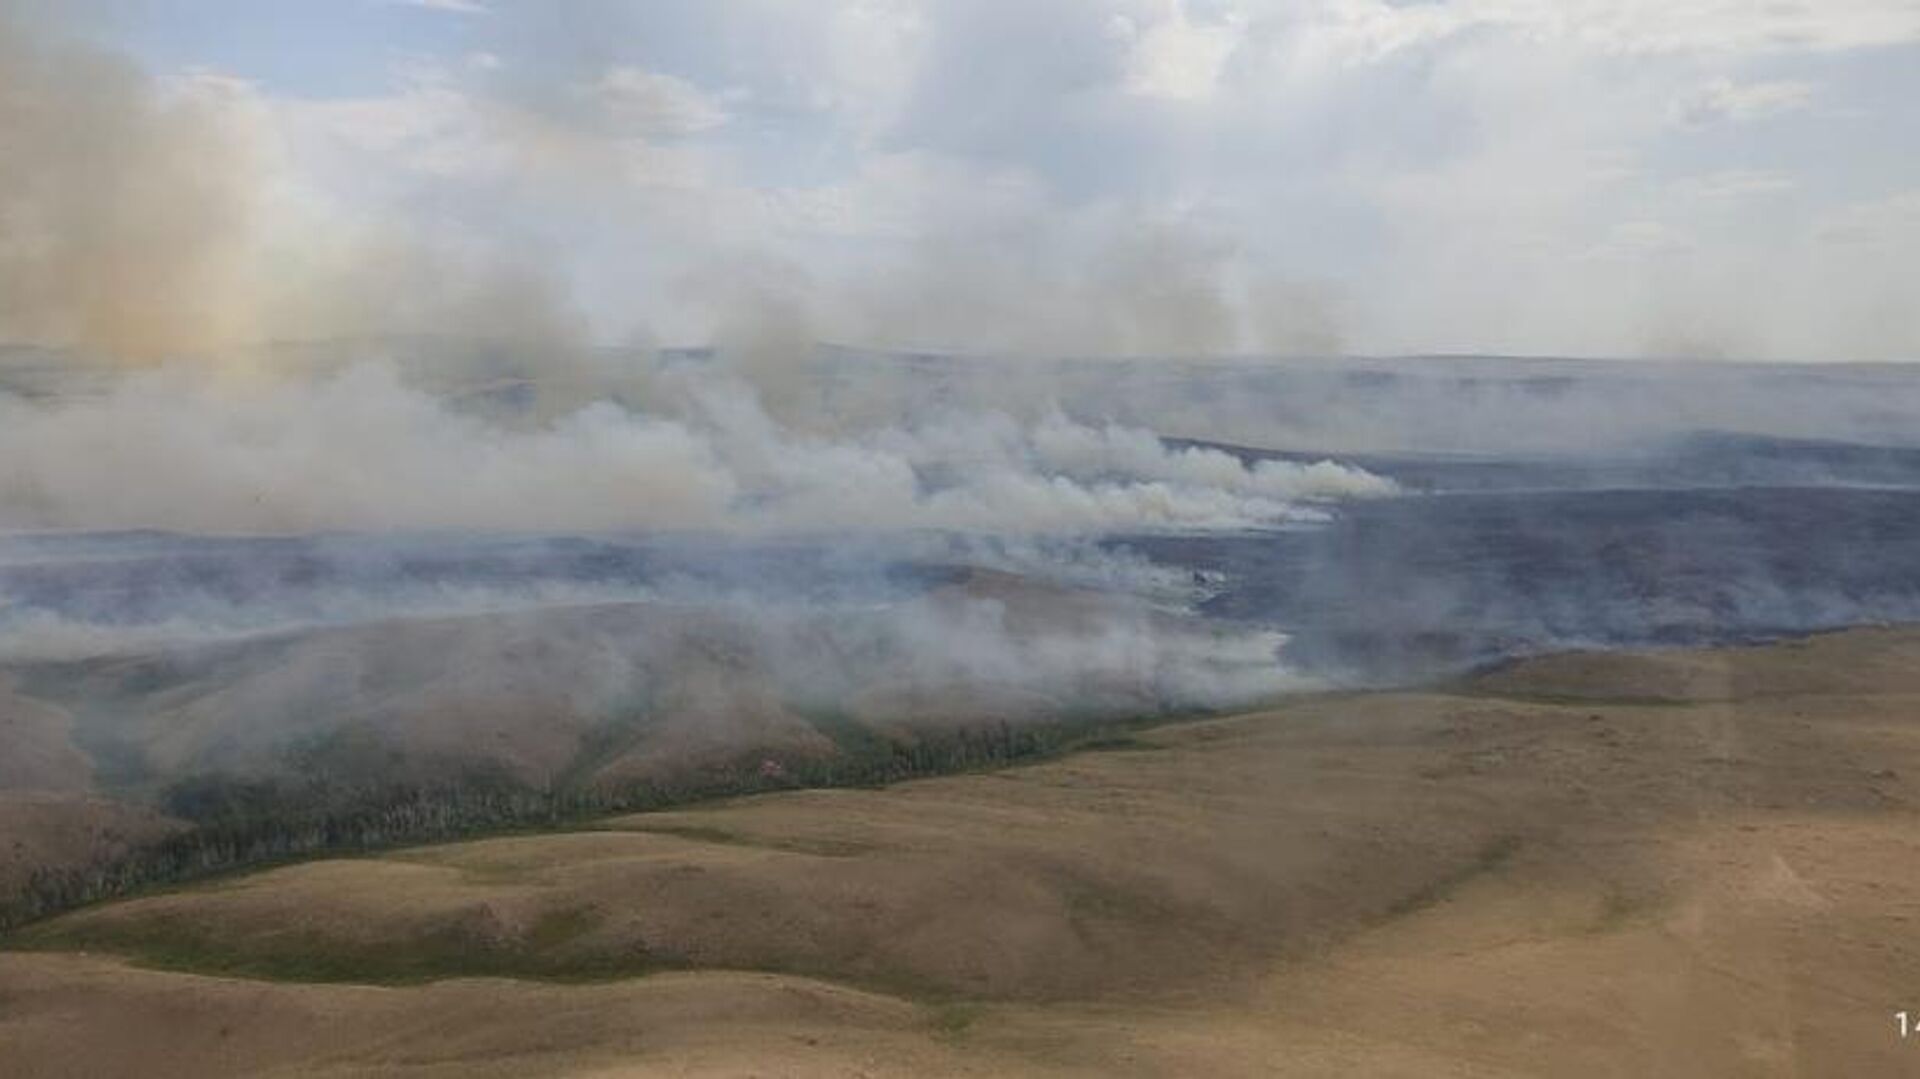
<box><xmin>11</xmin><ymin>449</ymin><xmax>1920</xmax><ymax>683</ymax></box>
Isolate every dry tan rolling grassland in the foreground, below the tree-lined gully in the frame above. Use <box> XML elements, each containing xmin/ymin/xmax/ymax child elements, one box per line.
<box><xmin>0</xmin><ymin>630</ymin><xmax>1920</xmax><ymax>1077</ymax></box>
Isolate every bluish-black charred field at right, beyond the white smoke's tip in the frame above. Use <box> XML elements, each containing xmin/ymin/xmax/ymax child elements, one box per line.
<box><xmin>1125</xmin><ymin>479</ymin><xmax>1920</xmax><ymax>683</ymax></box>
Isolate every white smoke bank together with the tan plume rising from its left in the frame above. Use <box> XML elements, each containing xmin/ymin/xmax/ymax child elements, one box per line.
<box><xmin>0</xmin><ymin>10</ymin><xmax>1388</xmax><ymax>532</ymax></box>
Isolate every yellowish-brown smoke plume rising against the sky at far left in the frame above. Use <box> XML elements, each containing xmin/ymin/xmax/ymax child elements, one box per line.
<box><xmin>0</xmin><ymin>10</ymin><xmax>257</xmax><ymax>359</ymax></box>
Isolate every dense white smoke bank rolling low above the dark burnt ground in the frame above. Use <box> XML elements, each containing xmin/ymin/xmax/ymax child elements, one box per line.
<box><xmin>0</xmin><ymin>365</ymin><xmax>1392</xmax><ymax>536</ymax></box>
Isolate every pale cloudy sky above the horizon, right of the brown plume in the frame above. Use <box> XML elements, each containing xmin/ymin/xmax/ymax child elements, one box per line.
<box><xmin>11</xmin><ymin>0</ymin><xmax>1920</xmax><ymax>361</ymax></box>
